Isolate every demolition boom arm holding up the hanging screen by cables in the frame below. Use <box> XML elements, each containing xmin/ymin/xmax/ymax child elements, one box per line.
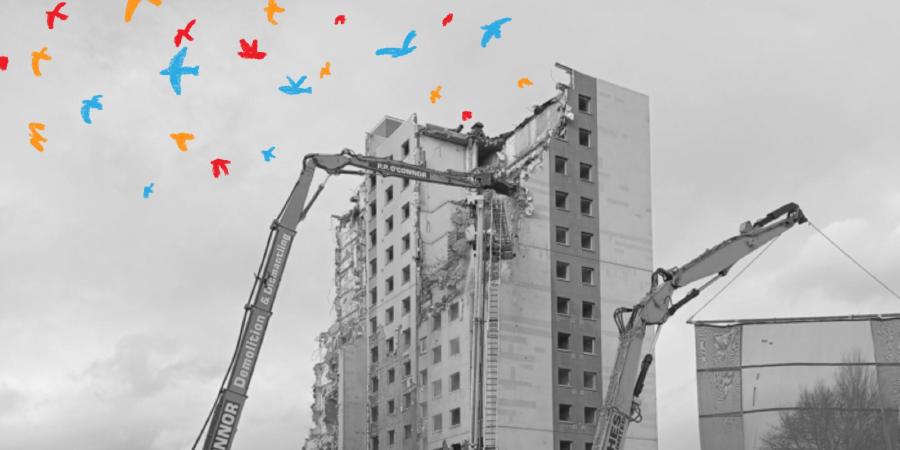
<box><xmin>593</xmin><ymin>203</ymin><xmax>806</xmax><ymax>450</ymax></box>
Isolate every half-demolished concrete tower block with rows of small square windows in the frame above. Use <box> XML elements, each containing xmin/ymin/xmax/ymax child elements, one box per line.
<box><xmin>306</xmin><ymin>66</ymin><xmax>657</xmax><ymax>450</ymax></box>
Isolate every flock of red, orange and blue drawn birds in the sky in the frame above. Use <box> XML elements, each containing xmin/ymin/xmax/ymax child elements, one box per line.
<box><xmin>10</xmin><ymin>0</ymin><xmax>532</xmax><ymax>199</ymax></box>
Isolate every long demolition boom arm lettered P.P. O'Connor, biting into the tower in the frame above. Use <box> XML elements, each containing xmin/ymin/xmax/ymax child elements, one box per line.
<box><xmin>200</xmin><ymin>149</ymin><xmax>515</xmax><ymax>450</ymax></box>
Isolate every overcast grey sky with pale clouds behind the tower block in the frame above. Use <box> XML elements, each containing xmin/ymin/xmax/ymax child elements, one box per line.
<box><xmin>0</xmin><ymin>0</ymin><xmax>900</xmax><ymax>450</ymax></box>
